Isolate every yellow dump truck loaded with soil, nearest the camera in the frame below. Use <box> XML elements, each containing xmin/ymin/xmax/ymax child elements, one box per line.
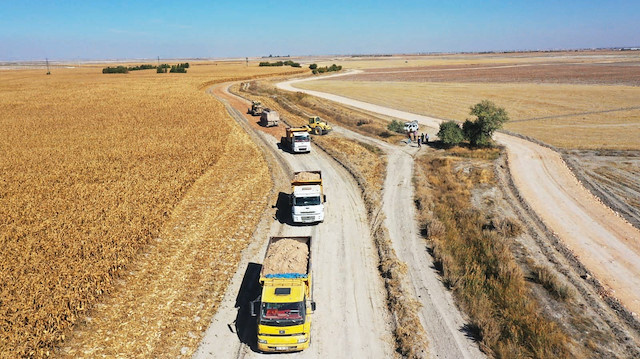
<box><xmin>251</xmin><ymin>237</ymin><xmax>316</xmax><ymax>352</ymax></box>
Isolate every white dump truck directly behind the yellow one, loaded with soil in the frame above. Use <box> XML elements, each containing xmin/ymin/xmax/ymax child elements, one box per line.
<box><xmin>290</xmin><ymin>171</ymin><xmax>327</xmax><ymax>223</ymax></box>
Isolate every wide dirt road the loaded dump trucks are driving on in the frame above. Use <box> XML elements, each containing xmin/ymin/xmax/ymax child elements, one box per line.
<box><xmin>194</xmin><ymin>85</ymin><xmax>394</xmax><ymax>358</ymax></box>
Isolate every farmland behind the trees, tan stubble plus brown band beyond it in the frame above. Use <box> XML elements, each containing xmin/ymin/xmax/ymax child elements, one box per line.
<box><xmin>299</xmin><ymin>53</ymin><xmax>640</xmax><ymax>150</ymax></box>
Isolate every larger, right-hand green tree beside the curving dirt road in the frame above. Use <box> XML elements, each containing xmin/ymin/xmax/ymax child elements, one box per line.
<box><xmin>462</xmin><ymin>100</ymin><xmax>509</xmax><ymax>146</ymax></box>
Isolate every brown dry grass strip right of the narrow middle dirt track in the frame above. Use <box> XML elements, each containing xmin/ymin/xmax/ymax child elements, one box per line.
<box><xmin>415</xmin><ymin>155</ymin><xmax>569</xmax><ymax>358</ymax></box>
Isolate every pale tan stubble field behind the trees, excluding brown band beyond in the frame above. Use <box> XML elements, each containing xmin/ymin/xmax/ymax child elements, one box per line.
<box><xmin>299</xmin><ymin>80</ymin><xmax>640</xmax><ymax>149</ymax></box>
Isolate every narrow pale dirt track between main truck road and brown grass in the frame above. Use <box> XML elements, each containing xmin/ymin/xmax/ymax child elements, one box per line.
<box><xmin>334</xmin><ymin>126</ymin><xmax>484</xmax><ymax>359</ymax></box>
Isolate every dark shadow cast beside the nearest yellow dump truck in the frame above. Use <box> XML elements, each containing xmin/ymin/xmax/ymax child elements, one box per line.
<box><xmin>235</xmin><ymin>262</ymin><xmax>262</xmax><ymax>352</ymax></box>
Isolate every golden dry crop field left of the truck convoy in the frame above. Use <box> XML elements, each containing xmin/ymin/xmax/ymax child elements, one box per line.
<box><xmin>0</xmin><ymin>63</ymin><xmax>302</xmax><ymax>357</ymax></box>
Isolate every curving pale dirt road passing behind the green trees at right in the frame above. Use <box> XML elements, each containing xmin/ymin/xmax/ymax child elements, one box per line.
<box><xmin>278</xmin><ymin>74</ymin><xmax>640</xmax><ymax>318</ymax></box>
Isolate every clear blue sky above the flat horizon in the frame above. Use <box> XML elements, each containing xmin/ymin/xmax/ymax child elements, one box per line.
<box><xmin>0</xmin><ymin>0</ymin><xmax>640</xmax><ymax>61</ymax></box>
